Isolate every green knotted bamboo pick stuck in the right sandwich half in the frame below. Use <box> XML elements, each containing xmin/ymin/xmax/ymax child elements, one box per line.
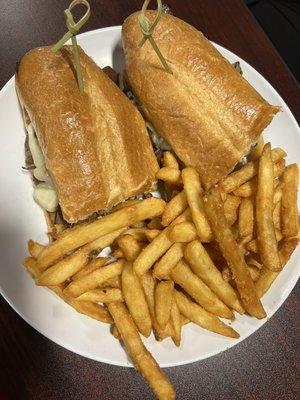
<box><xmin>138</xmin><ymin>0</ymin><xmax>173</xmax><ymax>74</ymax></box>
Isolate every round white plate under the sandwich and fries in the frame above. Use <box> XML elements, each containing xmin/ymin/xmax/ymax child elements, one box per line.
<box><xmin>0</xmin><ymin>27</ymin><xmax>300</xmax><ymax>367</ymax></box>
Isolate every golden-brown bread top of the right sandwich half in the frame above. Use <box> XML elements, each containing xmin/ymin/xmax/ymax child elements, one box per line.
<box><xmin>122</xmin><ymin>11</ymin><xmax>279</xmax><ymax>188</ymax></box>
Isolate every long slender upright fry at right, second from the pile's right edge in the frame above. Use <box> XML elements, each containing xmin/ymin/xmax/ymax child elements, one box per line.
<box><xmin>256</xmin><ymin>143</ymin><xmax>282</xmax><ymax>271</ymax></box>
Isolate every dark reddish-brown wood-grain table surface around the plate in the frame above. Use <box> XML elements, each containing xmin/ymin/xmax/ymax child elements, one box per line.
<box><xmin>0</xmin><ymin>0</ymin><xmax>300</xmax><ymax>400</ymax></box>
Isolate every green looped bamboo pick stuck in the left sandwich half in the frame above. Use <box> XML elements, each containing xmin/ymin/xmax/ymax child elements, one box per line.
<box><xmin>52</xmin><ymin>0</ymin><xmax>91</xmax><ymax>92</ymax></box>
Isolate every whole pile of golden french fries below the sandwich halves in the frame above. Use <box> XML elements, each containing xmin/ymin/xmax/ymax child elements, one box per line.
<box><xmin>23</xmin><ymin>139</ymin><xmax>299</xmax><ymax>400</ymax></box>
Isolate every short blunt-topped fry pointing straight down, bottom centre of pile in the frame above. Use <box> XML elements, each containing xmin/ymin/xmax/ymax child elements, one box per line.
<box><xmin>154</xmin><ymin>281</ymin><xmax>174</xmax><ymax>329</ymax></box>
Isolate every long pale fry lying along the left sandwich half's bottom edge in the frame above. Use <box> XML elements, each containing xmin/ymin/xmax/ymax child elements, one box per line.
<box><xmin>38</xmin><ymin>198</ymin><xmax>165</xmax><ymax>268</ymax></box>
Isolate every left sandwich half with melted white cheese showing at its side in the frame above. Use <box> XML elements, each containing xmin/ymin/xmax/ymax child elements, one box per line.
<box><xmin>16</xmin><ymin>46</ymin><xmax>159</xmax><ymax>223</ymax></box>
